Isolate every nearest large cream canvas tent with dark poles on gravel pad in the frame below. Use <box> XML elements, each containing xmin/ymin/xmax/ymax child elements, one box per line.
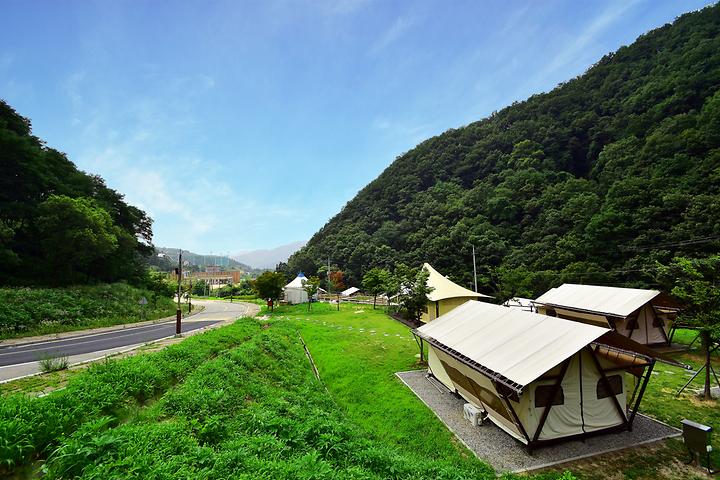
<box><xmin>414</xmin><ymin>300</ymin><xmax>655</xmax><ymax>449</ymax></box>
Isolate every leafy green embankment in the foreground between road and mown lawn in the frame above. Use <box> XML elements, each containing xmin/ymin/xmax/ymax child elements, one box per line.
<box><xmin>0</xmin><ymin>310</ymin><xmax>516</xmax><ymax>479</ymax></box>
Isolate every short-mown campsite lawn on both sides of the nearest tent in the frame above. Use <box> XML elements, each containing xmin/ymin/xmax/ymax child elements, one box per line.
<box><xmin>273</xmin><ymin>304</ymin><xmax>720</xmax><ymax>480</ymax></box>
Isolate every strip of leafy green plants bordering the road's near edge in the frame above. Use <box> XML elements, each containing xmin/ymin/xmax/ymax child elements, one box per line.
<box><xmin>0</xmin><ymin>322</ymin><xmax>260</xmax><ymax>476</ymax></box>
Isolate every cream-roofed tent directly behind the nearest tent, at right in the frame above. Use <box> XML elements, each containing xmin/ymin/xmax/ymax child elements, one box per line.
<box><xmin>534</xmin><ymin>283</ymin><xmax>678</xmax><ymax>345</ymax></box>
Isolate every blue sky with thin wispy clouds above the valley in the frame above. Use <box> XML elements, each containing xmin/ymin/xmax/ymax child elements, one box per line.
<box><xmin>0</xmin><ymin>0</ymin><xmax>708</xmax><ymax>253</ymax></box>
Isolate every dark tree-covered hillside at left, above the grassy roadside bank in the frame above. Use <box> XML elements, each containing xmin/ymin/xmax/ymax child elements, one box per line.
<box><xmin>0</xmin><ymin>100</ymin><xmax>153</xmax><ymax>285</ymax></box>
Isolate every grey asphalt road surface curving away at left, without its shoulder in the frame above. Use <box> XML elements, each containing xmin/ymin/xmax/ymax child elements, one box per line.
<box><xmin>0</xmin><ymin>301</ymin><xmax>251</xmax><ymax>367</ymax></box>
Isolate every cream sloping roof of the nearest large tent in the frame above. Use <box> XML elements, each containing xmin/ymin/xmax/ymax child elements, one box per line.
<box><xmin>416</xmin><ymin>300</ymin><xmax>610</xmax><ymax>390</ymax></box>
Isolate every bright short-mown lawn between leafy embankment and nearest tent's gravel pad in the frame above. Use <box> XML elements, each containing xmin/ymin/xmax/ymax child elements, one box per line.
<box><xmin>273</xmin><ymin>303</ymin><xmax>474</xmax><ymax>461</ymax></box>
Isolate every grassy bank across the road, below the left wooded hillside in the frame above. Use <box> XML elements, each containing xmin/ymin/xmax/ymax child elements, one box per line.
<box><xmin>0</xmin><ymin>283</ymin><xmax>187</xmax><ymax>339</ymax></box>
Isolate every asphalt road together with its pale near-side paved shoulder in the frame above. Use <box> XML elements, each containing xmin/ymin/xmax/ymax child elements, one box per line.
<box><xmin>0</xmin><ymin>301</ymin><xmax>258</xmax><ymax>382</ymax></box>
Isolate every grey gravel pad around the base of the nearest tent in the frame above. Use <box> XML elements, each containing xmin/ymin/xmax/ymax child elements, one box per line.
<box><xmin>396</xmin><ymin>370</ymin><xmax>681</xmax><ymax>472</ymax></box>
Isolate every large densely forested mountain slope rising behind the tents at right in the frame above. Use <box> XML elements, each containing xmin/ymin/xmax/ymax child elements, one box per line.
<box><xmin>288</xmin><ymin>5</ymin><xmax>720</xmax><ymax>296</ymax></box>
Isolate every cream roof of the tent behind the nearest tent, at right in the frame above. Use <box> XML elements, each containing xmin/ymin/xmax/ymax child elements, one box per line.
<box><xmin>535</xmin><ymin>283</ymin><xmax>660</xmax><ymax>317</ymax></box>
